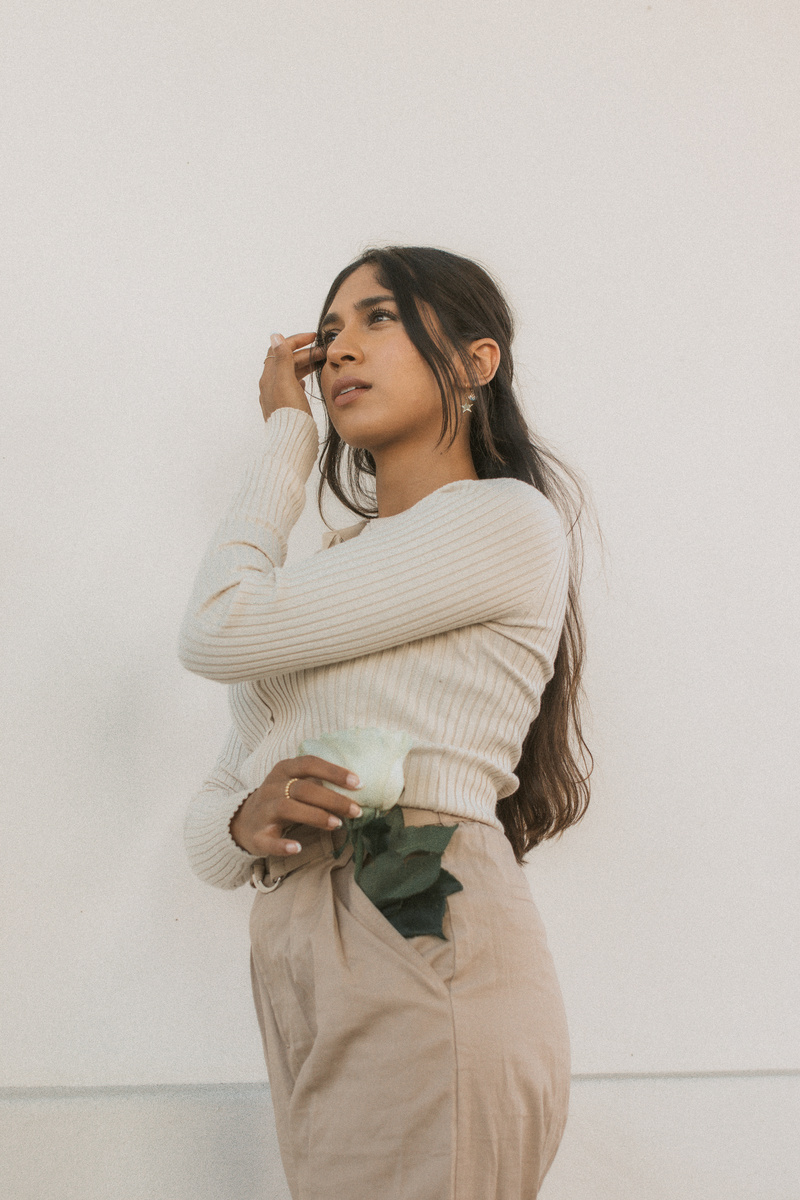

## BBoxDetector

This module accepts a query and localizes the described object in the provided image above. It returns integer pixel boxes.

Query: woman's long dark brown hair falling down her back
[315,246,594,864]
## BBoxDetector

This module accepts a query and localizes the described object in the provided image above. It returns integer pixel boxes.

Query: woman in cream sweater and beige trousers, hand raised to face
[180,246,589,1200]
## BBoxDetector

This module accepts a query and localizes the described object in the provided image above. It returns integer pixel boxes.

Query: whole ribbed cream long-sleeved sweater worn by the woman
[179,408,569,888]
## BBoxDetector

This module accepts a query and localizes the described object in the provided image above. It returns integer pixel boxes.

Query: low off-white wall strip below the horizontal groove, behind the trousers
[6,1075,800,1200]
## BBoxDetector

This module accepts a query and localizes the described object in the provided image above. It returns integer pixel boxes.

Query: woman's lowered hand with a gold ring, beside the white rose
[230,755,361,858]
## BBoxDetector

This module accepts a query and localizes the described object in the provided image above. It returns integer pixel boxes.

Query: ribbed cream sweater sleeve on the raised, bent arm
[179,408,567,683]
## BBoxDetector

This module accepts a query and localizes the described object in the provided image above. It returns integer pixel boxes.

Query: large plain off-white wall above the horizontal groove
[0,0,800,1190]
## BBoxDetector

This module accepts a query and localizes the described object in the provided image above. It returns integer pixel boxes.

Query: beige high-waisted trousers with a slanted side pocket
[251,806,570,1200]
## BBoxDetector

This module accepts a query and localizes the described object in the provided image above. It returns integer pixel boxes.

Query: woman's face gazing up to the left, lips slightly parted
[320,263,455,451]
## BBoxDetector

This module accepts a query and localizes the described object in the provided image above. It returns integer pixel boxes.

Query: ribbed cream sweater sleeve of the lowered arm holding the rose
[184,725,258,888]
